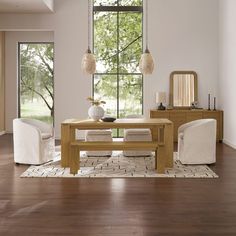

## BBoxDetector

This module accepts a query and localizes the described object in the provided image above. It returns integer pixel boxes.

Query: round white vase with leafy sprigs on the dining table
[87,97,106,121]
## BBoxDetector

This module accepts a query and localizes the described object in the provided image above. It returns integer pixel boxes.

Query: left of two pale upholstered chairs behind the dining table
[85,129,112,156]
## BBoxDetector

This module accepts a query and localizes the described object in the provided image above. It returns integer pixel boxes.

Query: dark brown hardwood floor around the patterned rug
[0,135,236,236]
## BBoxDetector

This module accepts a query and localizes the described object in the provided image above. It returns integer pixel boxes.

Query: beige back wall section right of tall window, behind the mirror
[145,0,218,114]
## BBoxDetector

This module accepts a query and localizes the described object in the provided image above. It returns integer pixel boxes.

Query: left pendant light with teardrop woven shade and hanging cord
[81,0,96,74]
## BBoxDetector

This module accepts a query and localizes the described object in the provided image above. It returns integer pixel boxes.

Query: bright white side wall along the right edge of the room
[219,0,236,148]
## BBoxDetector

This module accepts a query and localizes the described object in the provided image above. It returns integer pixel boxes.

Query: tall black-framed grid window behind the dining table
[93,0,143,135]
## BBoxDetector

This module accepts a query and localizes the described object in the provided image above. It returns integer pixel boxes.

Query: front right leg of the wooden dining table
[164,123,174,168]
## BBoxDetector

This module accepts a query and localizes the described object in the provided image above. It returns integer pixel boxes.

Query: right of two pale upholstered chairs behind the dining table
[123,115,152,156]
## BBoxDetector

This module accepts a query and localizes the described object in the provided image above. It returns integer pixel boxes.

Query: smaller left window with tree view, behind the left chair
[19,43,54,124]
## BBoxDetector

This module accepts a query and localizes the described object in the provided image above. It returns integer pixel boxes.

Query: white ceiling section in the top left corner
[0,0,53,13]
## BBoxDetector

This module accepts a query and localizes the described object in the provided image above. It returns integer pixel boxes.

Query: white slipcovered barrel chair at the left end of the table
[13,118,55,165]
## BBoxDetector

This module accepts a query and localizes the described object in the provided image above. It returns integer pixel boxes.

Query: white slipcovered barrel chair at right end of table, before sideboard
[178,119,216,164]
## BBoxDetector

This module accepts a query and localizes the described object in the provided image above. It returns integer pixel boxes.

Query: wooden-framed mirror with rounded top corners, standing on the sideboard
[169,71,198,108]
